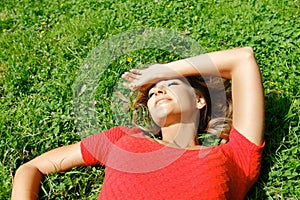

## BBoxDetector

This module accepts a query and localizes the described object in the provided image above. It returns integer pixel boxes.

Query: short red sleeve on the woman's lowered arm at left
[80,126,128,165]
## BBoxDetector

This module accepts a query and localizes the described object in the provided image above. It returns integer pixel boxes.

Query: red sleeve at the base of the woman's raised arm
[224,127,265,183]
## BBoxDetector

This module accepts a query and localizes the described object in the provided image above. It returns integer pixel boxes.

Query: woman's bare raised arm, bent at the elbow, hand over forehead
[123,47,264,145]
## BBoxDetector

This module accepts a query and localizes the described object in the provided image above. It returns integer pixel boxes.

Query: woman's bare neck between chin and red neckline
[161,123,197,148]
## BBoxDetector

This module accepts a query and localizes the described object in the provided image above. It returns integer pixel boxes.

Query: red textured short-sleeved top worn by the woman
[81,126,264,200]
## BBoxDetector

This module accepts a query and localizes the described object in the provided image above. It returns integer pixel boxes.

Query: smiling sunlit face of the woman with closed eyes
[147,79,199,127]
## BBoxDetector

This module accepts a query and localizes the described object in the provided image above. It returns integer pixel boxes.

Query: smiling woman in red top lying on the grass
[12,47,264,200]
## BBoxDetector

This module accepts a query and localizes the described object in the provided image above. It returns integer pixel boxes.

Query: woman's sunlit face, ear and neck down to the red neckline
[147,79,205,148]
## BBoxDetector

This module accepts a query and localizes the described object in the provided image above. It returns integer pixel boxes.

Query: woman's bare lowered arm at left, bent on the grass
[11,142,84,200]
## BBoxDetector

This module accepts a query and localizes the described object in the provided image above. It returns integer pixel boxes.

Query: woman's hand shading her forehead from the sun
[122,64,181,91]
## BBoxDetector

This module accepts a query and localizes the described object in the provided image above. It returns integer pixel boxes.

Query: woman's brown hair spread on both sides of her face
[132,76,232,143]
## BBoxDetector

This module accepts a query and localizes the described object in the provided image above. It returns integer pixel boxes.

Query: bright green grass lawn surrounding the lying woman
[0,0,300,199]
